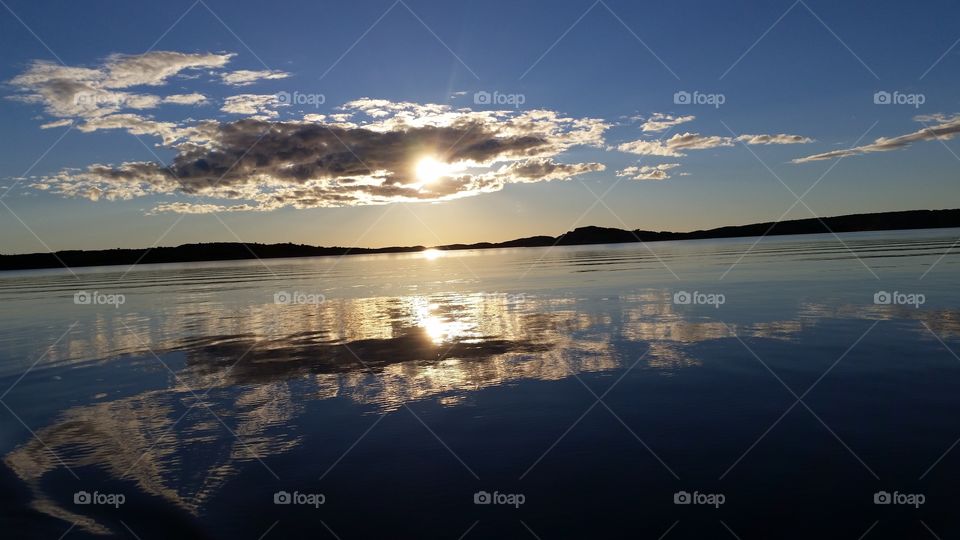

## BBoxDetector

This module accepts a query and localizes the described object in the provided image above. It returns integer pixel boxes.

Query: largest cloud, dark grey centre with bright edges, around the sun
[33,100,607,213]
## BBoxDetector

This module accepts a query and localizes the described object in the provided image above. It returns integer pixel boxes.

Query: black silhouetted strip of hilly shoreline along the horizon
[0,209,960,271]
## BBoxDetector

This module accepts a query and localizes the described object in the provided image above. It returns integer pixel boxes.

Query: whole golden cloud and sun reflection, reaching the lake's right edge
[4,233,960,533]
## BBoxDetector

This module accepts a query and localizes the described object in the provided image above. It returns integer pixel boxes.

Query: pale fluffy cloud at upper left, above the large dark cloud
[9,51,233,118]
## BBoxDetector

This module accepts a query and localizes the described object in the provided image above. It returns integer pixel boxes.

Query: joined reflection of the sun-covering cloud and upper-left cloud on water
[4,293,632,533]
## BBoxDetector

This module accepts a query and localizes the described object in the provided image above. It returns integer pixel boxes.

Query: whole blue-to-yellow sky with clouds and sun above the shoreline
[0,0,960,253]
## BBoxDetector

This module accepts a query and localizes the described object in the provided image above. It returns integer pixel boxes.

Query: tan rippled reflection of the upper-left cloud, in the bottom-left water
[4,383,302,534]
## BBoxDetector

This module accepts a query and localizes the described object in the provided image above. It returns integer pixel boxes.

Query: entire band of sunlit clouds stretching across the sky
[8,51,832,213]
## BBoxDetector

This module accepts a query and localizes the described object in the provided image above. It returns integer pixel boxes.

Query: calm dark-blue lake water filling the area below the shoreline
[0,229,960,540]
